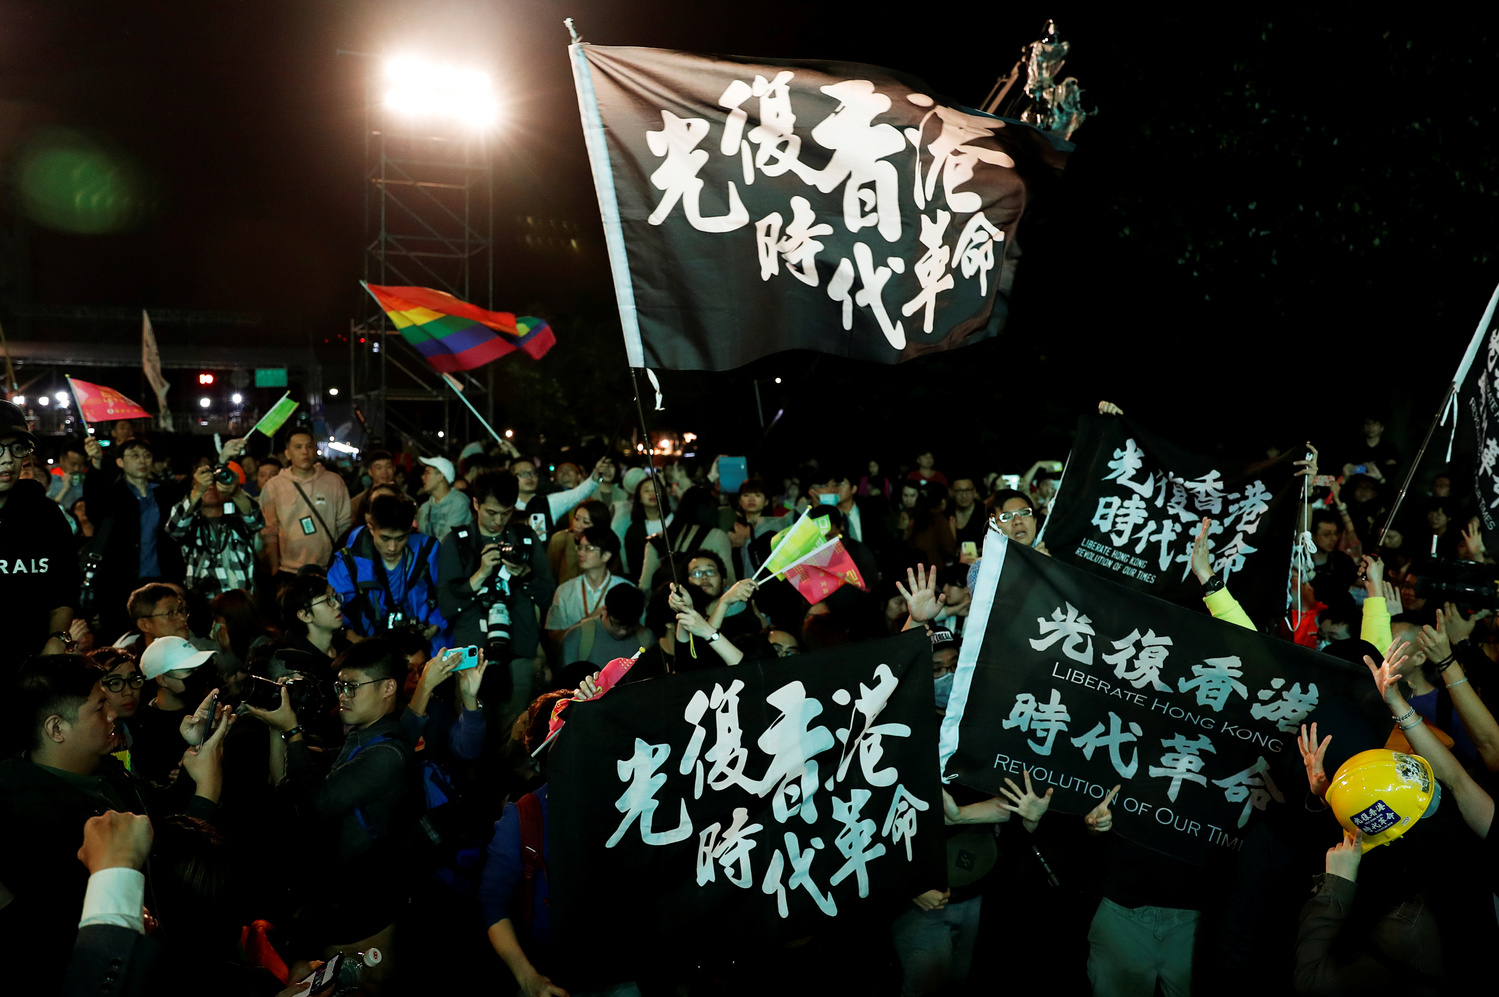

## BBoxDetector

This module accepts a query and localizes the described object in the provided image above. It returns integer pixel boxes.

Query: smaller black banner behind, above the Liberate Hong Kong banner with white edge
[1042,412,1301,627]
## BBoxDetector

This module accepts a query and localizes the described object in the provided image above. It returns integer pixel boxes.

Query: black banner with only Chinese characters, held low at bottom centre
[547,630,946,960]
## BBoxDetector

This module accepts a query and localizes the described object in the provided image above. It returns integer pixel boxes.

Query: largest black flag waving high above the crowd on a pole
[571,45,1072,370]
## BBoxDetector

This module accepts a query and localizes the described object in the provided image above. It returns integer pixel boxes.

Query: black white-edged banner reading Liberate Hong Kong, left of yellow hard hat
[941,532,1390,862]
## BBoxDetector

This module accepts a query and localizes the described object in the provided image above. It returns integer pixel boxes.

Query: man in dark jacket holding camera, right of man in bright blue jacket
[438,471,556,712]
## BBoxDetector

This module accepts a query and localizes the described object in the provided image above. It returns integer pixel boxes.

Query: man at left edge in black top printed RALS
[0,402,78,661]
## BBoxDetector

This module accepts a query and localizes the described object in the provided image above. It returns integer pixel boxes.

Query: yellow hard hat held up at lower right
[1327,748,1442,852]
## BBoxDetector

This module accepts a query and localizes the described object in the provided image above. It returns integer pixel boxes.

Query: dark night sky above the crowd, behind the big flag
[0,0,1499,471]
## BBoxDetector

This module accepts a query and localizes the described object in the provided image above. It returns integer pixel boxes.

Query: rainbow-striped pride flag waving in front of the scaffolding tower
[361,282,556,373]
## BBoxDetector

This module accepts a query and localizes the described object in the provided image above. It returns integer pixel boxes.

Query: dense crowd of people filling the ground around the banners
[0,402,1499,997]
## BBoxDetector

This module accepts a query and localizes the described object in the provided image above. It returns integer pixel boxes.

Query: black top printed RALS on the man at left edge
[0,480,78,660]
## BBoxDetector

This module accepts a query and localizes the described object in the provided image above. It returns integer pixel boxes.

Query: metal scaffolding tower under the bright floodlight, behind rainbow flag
[349,73,495,445]
